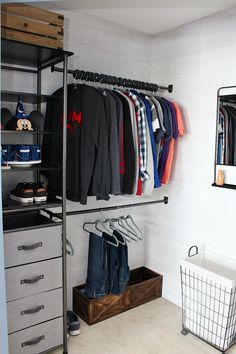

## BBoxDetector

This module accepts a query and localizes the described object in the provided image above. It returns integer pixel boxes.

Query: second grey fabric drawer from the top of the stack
[6,258,62,301]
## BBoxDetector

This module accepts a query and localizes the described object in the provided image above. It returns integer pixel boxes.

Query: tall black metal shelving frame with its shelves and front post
[1,38,70,353]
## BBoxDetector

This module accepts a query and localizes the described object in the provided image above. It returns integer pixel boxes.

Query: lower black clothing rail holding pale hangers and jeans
[44,196,168,219]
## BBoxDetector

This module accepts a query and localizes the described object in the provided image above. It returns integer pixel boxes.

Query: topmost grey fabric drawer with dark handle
[4,225,62,268]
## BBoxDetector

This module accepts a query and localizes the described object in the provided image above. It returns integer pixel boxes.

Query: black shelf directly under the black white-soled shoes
[2,198,62,215]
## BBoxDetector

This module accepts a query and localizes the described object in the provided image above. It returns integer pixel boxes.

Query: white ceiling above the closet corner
[33,0,236,35]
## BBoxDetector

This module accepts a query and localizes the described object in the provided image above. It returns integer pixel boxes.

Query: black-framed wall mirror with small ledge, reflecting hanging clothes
[213,86,236,189]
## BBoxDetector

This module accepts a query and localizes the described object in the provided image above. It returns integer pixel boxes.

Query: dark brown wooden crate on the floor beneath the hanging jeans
[73,267,163,325]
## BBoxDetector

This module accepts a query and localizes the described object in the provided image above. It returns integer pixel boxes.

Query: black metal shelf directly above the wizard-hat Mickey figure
[1,90,62,104]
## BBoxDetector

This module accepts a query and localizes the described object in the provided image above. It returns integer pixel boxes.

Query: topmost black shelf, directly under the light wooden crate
[1,38,73,70]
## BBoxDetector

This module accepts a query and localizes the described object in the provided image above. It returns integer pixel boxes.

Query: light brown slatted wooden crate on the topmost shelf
[1,3,64,49]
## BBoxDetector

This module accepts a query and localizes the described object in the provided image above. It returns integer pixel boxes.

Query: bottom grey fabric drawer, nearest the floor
[8,317,63,354]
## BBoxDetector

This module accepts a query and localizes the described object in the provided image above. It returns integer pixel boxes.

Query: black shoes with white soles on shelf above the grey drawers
[9,182,47,204]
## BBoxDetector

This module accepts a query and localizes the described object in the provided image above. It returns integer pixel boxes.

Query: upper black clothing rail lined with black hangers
[51,65,173,93]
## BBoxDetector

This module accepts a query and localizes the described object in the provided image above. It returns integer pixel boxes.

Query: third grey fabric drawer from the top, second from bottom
[7,289,62,333]
